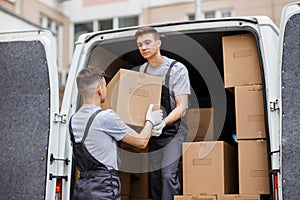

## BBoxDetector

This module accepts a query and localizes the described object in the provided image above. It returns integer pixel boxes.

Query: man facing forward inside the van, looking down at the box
[135,26,190,200]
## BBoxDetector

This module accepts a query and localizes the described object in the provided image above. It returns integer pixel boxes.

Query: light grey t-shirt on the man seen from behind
[72,104,130,170]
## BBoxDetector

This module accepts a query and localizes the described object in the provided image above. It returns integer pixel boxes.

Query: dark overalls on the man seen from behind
[69,109,120,200]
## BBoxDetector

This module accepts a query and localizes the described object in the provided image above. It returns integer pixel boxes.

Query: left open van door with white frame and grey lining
[0,30,59,200]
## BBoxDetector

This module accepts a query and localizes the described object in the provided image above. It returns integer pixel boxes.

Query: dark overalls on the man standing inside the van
[144,61,186,200]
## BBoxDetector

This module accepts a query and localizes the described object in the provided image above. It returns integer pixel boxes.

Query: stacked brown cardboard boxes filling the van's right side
[175,34,270,200]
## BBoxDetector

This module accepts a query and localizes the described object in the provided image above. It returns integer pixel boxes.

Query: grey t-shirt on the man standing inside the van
[140,56,191,109]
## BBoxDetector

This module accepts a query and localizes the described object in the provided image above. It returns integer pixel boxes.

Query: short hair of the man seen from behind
[76,66,104,97]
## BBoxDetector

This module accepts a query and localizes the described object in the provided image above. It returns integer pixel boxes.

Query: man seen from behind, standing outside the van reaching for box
[69,67,163,200]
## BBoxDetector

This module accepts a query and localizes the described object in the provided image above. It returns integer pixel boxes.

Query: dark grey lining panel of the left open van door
[0,41,50,200]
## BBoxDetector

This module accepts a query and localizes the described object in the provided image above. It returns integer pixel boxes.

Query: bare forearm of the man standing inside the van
[164,94,188,125]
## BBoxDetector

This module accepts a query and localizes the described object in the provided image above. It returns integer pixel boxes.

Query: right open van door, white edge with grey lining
[278,3,300,200]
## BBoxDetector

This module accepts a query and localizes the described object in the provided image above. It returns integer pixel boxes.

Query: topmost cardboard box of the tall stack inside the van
[222,34,262,88]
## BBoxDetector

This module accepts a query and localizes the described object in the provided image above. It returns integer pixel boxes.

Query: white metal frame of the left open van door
[0,30,59,199]
